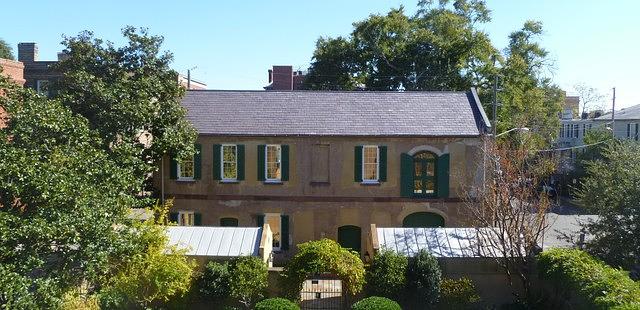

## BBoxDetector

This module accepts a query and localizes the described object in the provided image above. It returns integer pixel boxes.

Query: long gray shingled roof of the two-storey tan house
[182,90,489,136]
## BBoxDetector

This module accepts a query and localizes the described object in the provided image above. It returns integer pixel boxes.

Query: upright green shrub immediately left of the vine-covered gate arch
[229,256,268,309]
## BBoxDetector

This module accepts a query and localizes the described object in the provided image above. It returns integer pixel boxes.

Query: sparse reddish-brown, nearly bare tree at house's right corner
[467,140,555,302]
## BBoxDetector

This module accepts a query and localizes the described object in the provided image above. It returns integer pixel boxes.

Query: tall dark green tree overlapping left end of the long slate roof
[56,27,196,179]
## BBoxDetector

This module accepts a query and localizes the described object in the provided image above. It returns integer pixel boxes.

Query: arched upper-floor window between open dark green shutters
[413,151,438,197]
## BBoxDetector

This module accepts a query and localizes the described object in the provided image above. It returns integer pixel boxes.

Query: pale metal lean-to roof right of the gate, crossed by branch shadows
[376,227,504,257]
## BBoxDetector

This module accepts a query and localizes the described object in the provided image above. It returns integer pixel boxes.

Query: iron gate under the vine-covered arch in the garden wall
[300,274,346,310]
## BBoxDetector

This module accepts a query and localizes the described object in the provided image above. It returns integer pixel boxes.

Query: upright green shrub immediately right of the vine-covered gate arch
[366,249,408,300]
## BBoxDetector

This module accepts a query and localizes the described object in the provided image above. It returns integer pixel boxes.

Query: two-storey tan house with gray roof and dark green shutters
[154,90,490,260]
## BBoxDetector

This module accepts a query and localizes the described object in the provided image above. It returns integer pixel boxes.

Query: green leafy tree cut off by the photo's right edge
[576,141,640,270]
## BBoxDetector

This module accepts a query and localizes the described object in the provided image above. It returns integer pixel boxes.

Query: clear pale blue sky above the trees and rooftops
[0,0,640,107]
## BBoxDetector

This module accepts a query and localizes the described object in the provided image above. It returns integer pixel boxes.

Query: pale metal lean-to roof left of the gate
[167,226,262,257]
